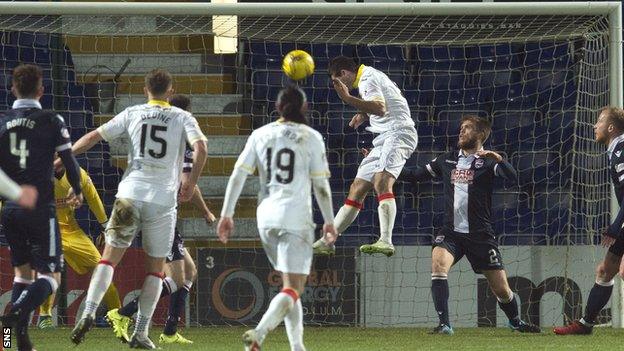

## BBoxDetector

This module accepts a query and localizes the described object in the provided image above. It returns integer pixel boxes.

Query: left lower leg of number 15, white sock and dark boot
[70,244,126,345]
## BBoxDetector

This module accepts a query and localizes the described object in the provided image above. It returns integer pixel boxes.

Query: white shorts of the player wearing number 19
[258,228,314,275]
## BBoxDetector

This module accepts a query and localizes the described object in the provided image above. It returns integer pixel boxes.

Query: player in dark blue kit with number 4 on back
[0,65,82,351]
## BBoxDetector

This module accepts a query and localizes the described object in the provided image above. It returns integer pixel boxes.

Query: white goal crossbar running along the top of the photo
[0,1,621,16]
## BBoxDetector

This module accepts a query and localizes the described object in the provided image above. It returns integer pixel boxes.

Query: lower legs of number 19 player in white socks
[243,273,308,351]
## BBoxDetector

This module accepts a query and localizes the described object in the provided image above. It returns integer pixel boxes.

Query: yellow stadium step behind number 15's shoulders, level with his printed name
[93,115,251,138]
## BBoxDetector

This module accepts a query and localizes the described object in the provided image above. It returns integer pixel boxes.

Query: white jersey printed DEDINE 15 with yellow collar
[98,101,206,206]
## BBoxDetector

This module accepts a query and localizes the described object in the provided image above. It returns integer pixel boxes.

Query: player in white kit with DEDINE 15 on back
[71,69,207,349]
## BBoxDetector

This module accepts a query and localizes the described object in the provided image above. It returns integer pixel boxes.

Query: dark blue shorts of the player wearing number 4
[0,205,63,273]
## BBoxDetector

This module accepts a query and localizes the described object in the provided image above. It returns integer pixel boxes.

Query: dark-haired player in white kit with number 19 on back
[217,87,337,351]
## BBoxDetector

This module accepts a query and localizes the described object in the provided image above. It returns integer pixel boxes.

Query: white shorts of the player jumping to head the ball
[355,127,418,183]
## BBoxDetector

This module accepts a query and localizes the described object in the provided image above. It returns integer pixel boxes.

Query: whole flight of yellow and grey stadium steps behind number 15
[64,31,255,241]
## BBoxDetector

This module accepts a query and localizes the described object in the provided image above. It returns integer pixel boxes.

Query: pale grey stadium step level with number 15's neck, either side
[115,94,243,114]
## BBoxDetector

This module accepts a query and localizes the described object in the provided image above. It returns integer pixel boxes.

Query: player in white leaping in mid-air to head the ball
[314,56,418,256]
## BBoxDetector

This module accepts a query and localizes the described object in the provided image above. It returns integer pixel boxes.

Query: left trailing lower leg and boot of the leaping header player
[312,178,373,255]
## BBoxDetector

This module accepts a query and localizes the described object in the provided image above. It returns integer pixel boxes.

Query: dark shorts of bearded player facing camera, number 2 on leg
[433,231,504,273]
